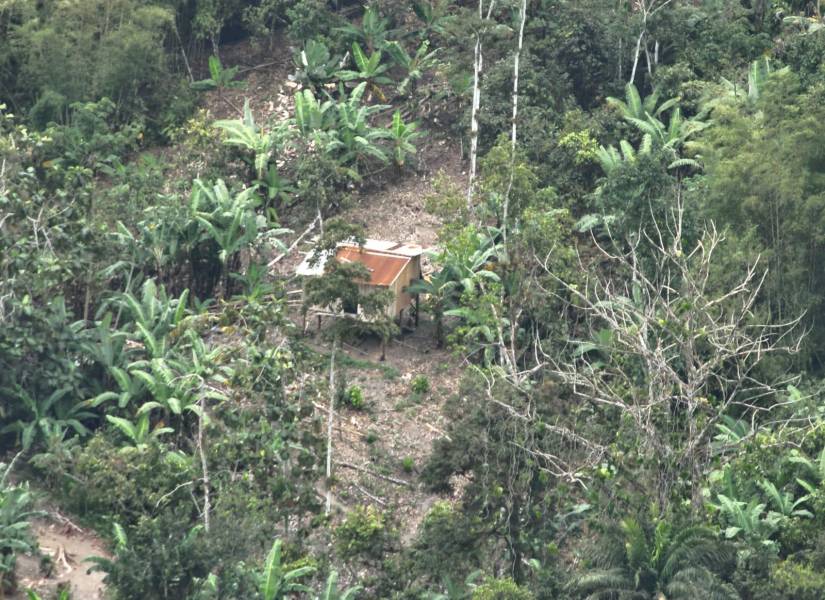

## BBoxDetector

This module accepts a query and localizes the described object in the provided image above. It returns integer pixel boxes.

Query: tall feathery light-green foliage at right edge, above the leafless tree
[702,72,825,358]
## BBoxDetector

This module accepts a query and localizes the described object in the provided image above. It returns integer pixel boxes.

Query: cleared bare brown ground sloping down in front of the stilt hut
[308,319,459,542]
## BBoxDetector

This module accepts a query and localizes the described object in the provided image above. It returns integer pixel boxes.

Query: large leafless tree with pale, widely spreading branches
[544,209,802,508]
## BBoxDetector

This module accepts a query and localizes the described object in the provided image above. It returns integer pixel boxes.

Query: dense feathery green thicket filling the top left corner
[4,0,175,121]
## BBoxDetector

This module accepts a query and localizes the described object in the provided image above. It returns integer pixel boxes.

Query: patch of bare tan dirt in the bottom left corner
[10,520,107,600]
